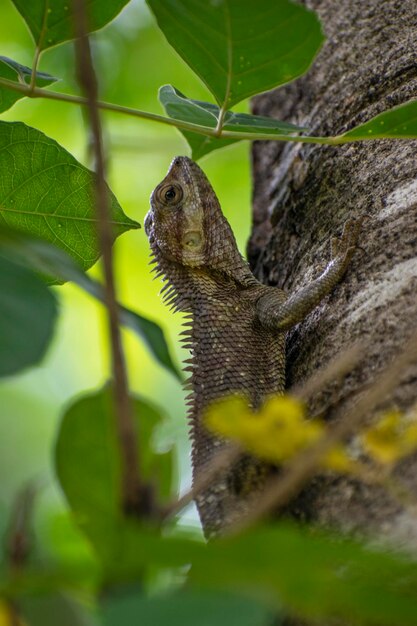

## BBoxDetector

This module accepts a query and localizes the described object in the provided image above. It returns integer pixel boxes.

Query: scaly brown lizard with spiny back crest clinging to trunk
[145,156,361,537]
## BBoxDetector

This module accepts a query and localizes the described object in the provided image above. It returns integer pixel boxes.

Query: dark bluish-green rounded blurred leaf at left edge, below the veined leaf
[0,256,57,376]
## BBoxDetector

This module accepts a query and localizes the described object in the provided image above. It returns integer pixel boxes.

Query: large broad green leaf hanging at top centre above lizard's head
[147,0,323,109]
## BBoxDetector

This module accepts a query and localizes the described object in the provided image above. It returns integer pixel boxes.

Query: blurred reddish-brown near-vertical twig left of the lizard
[73,0,146,516]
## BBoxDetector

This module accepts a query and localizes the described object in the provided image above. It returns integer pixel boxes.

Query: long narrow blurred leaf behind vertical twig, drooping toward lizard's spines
[0,227,182,380]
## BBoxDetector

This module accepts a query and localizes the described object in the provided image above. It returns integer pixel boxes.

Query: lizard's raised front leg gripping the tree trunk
[257,219,362,331]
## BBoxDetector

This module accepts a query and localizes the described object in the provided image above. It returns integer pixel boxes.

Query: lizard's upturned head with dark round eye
[145,157,243,273]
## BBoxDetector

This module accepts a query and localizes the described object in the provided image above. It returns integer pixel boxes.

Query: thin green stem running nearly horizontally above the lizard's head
[0,78,415,146]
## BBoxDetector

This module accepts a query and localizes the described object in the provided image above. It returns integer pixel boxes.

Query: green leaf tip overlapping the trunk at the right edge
[337,100,417,140]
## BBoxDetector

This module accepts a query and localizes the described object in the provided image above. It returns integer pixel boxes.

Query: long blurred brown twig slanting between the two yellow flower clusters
[230,333,417,534]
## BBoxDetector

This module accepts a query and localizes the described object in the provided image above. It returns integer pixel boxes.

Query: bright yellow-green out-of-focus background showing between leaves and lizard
[0,0,250,540]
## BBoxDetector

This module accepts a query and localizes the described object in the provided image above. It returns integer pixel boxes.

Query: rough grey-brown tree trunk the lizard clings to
[248,0,417,547]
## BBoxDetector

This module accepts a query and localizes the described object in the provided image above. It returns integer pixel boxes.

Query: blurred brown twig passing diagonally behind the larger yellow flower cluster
[165,344,363,517]
